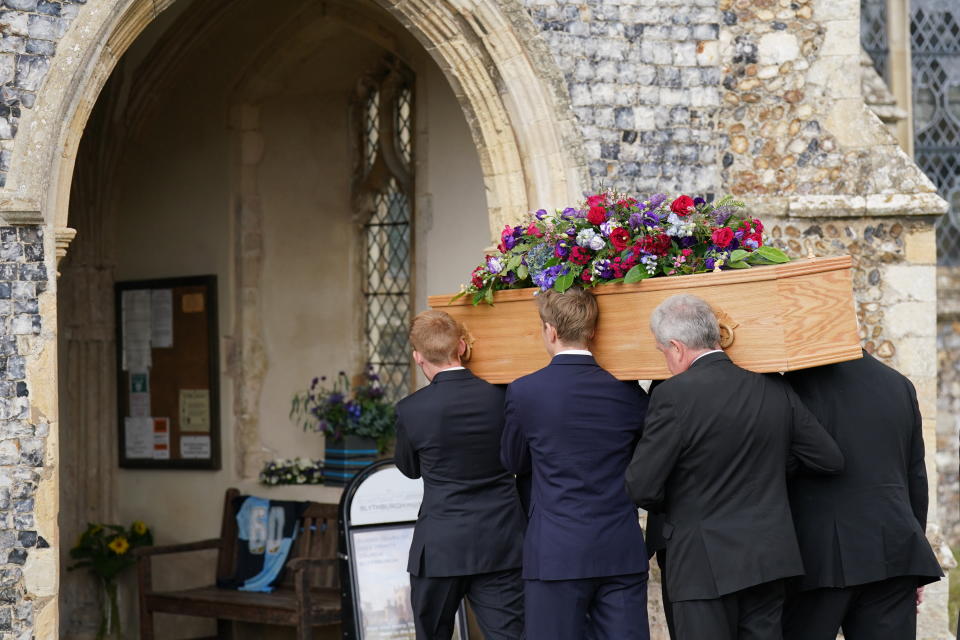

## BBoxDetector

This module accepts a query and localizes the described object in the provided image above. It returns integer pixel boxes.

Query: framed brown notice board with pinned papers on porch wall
[115,276,220,469]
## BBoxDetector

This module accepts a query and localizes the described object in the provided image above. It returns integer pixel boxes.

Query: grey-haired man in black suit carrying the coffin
[626,295,843,640]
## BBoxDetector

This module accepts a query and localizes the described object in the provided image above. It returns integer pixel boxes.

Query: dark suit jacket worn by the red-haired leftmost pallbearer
[396,369,526,578]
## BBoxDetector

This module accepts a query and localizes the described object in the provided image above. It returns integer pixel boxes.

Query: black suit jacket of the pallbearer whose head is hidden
[786,352,942,589]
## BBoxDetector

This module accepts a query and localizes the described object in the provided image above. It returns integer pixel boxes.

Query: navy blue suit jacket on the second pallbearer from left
[502,355,648,580]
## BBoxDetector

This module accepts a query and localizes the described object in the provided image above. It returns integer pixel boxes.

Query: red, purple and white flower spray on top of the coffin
[455,192,789,304]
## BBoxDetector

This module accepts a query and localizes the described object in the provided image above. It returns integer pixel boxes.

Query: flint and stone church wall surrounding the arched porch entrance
[0,0,944,640]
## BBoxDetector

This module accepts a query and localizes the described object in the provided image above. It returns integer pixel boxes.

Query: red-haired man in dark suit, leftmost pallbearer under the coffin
[396,311,526,640]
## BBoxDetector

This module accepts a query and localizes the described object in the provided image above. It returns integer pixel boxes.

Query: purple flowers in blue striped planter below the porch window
[290,366,396,485]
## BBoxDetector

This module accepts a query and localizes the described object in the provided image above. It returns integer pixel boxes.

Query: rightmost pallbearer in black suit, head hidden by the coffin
[783,352,942,640]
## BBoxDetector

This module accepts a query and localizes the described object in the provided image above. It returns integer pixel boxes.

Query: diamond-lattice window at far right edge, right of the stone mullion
[910,0,960,265]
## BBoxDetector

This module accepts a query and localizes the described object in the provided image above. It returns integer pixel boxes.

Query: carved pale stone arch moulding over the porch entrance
[13,0,586,244]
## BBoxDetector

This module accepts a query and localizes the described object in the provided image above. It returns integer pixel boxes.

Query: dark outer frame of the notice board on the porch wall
[114,275,222,471]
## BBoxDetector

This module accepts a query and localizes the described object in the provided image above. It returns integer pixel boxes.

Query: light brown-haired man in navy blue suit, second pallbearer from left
[502,288,649,640]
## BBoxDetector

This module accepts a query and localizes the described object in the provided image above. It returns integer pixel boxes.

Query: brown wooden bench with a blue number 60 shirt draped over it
[134,489,340,640]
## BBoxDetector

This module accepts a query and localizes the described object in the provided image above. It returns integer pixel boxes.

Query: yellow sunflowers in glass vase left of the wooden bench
[70,520,153,639]
